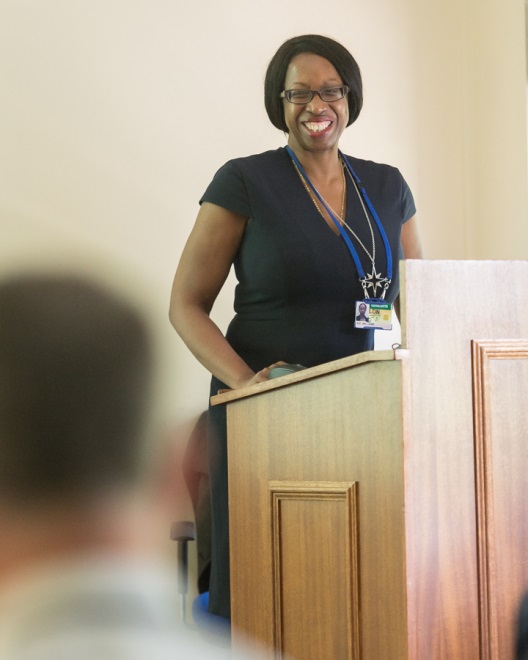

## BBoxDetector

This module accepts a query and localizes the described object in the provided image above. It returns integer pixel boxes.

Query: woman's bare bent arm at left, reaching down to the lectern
[169,202,268,389]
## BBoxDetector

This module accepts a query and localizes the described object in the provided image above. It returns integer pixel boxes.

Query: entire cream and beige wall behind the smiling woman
[0,0,528,424]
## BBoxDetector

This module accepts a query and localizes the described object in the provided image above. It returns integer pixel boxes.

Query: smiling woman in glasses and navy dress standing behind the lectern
[170,29,421,617]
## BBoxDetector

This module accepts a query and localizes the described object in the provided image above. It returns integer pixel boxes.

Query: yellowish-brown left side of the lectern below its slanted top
[228,356,407,660]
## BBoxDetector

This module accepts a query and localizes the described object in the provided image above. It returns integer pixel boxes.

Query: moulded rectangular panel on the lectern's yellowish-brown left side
[269,482,360,660]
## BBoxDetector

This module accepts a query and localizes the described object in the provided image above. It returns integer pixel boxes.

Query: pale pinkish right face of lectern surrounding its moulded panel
[401,261,528,660]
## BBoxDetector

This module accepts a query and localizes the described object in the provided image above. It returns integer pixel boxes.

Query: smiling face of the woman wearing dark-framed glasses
[283,53,349,156]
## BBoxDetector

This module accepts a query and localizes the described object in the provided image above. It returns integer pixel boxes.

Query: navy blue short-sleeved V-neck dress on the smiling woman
[201,148,415,617]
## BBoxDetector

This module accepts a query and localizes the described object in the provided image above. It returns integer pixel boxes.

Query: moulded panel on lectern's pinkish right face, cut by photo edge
[472,340,528,660]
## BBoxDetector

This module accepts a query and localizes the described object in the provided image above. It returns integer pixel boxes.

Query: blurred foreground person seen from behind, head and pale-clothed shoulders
[0,273,227,660]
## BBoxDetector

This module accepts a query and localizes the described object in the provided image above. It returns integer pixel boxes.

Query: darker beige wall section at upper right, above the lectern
[412,0,528,259]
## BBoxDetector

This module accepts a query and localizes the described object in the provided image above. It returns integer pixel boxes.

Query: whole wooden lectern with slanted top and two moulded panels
[213,261,528,660]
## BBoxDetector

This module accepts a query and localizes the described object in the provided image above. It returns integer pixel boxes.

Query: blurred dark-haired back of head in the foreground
[0,274,163,561]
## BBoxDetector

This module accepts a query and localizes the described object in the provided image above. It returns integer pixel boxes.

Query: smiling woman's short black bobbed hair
[264,34,363,133]
